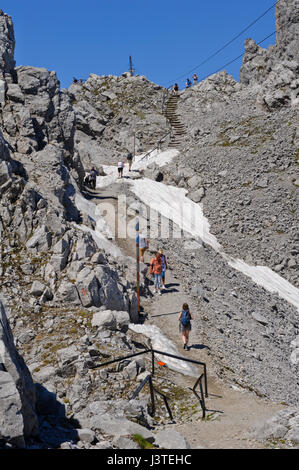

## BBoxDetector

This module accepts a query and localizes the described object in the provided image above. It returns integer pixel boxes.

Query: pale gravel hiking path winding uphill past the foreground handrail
[98,182,283,449]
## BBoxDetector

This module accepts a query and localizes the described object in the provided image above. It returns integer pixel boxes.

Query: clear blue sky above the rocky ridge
[0,0,275,88]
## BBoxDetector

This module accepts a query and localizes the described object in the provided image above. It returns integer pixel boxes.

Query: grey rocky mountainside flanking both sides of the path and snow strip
[0,0,299,449]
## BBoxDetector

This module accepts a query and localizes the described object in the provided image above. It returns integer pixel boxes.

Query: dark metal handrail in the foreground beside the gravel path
[89,348,208,419]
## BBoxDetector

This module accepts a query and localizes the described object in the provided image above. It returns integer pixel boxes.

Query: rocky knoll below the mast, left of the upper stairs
[67,73,169,168]
